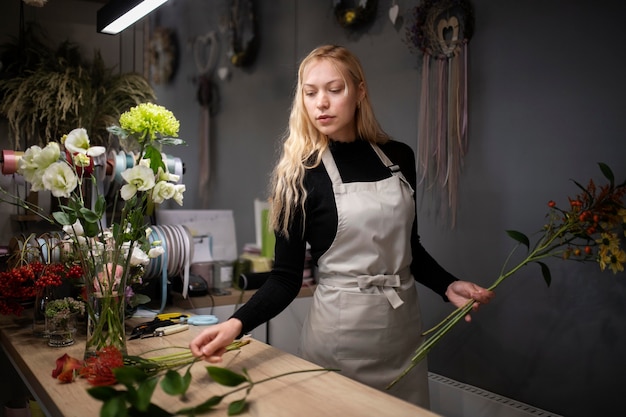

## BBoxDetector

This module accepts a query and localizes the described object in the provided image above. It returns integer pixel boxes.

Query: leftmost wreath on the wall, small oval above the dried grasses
[149,28,178,84]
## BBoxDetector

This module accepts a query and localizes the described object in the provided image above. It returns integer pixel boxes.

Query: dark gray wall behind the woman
[2,0,626,417]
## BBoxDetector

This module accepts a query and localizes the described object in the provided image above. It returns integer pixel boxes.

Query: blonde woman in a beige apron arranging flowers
[190,45,493,407]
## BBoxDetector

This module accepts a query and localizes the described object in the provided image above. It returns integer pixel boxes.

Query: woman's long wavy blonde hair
[270,45,389,237]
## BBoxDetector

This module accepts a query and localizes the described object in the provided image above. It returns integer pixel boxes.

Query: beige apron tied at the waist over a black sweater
[300,145,429,408]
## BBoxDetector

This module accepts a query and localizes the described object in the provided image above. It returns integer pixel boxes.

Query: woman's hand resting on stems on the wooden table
[189,319,243,363]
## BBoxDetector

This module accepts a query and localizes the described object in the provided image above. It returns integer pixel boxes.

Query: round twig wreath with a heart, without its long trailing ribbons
[407,0,474,57]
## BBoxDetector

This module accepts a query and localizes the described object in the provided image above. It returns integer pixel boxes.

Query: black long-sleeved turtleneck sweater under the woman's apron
[233,140,456,333]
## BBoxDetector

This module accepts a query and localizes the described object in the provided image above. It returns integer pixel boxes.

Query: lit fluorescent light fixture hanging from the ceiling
[97,0,167,35]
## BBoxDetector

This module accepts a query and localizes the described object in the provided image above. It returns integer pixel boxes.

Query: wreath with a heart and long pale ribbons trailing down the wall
[407,0,474,228]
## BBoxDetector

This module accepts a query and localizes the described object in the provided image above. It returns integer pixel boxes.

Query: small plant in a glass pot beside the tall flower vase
[46,297,85,347]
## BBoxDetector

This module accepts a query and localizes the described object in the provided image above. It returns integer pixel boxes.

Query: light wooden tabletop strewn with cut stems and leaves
[0,317,436,417]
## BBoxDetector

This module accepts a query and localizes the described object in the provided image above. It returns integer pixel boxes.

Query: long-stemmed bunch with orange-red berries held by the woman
[387,163,626,389]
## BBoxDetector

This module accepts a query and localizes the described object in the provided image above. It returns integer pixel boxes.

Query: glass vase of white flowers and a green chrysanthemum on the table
[0,103,185,357]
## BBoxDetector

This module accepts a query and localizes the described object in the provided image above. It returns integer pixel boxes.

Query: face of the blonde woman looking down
[302,59,365,142]
